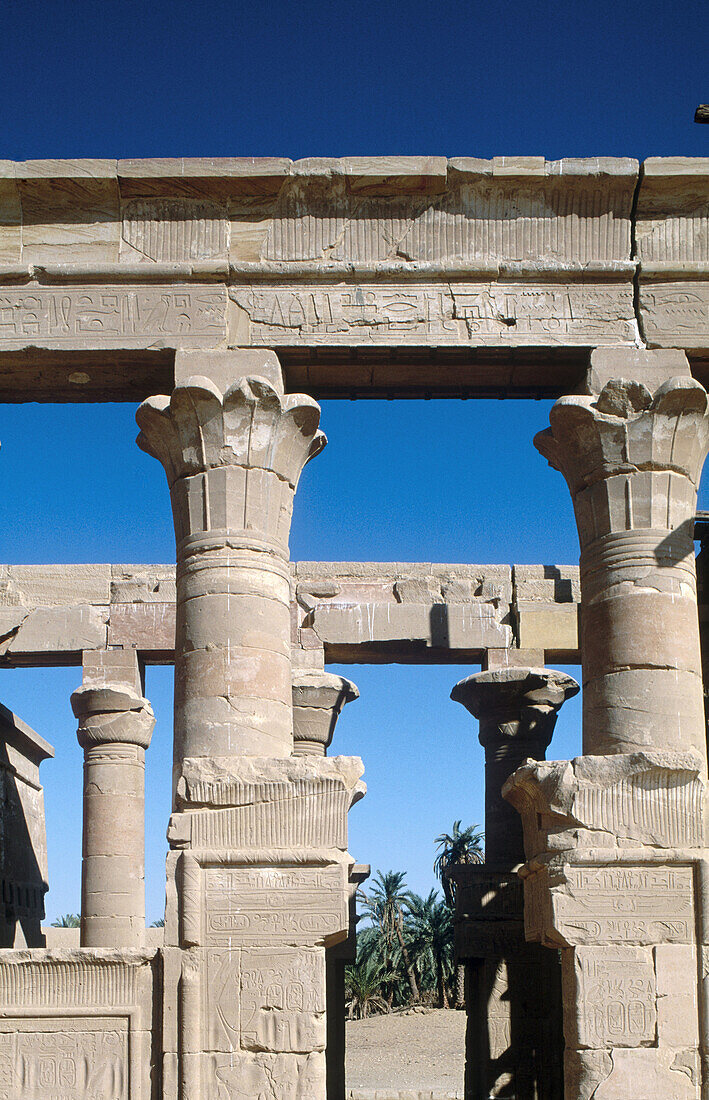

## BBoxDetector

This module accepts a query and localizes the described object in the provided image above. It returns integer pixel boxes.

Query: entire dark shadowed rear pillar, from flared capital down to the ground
[451,667,578,1100]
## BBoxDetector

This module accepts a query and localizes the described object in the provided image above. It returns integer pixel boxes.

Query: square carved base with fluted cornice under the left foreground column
[163,757,364,1100]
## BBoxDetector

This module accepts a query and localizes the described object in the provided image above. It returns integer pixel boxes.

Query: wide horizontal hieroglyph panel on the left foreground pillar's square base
[203,865,347,947]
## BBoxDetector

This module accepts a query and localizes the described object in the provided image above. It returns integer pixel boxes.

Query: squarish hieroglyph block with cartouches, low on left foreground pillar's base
[241,948,325,1054]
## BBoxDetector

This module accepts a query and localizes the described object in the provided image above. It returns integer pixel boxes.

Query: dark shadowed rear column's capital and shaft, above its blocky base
[451,668,578,869]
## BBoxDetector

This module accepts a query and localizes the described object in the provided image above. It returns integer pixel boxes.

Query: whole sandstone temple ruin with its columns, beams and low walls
[0,157,709,1100]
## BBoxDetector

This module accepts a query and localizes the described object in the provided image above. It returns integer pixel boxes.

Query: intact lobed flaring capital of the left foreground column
[135,376,326,550]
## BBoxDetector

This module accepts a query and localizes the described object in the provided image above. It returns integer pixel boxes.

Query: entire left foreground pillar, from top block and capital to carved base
[137,350,364,1100]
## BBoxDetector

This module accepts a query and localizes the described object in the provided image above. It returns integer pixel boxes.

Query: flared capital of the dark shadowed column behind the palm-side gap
[451,667,579,751]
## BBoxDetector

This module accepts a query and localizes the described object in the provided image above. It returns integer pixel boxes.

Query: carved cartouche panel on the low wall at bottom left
[0,1016,129,1100]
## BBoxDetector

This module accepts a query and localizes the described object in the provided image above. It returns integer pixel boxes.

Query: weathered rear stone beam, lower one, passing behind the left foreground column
[0,562,602,669]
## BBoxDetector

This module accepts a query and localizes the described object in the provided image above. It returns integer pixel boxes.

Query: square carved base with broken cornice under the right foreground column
[505,752,709,1100]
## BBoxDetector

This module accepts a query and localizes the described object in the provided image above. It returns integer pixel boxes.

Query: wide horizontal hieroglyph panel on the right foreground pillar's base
[552,866,694,944]
